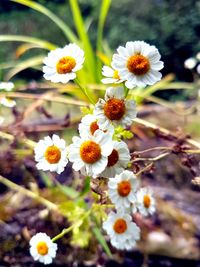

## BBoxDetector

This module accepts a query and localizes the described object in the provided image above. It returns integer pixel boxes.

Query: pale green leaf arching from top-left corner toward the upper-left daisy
[11,0,78,43]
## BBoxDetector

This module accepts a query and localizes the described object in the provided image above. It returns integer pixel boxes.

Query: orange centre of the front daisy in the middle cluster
[80,141,101,164]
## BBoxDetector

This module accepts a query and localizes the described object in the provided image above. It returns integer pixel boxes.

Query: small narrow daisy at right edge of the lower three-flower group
[136,187,156,216]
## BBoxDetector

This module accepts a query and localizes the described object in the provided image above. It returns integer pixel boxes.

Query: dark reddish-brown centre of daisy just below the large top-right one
[104,98,126,120]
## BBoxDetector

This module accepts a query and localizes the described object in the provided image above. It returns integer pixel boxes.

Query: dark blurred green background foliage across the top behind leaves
[0,0,200,81]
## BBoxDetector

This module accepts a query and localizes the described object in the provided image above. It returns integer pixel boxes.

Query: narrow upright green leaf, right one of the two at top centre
[96,0,111,81]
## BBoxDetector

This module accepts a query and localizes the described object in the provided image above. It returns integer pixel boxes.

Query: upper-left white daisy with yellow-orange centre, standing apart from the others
[43,44,84,83]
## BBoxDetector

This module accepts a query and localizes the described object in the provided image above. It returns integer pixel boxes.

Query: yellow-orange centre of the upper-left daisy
[56,56,76,74]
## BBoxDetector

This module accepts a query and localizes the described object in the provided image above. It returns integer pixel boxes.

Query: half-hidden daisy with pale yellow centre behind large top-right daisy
[101,66,123,84]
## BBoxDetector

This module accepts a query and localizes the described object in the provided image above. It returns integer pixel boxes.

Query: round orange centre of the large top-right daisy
[127,55,150,75]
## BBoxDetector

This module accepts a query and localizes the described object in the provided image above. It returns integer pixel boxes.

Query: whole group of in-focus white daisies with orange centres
[30,41,163,264]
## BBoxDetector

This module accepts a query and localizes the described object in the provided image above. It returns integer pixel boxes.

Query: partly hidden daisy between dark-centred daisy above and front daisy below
[78,114,114,138]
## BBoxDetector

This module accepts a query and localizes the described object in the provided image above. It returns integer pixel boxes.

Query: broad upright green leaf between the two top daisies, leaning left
[69,0,97,82]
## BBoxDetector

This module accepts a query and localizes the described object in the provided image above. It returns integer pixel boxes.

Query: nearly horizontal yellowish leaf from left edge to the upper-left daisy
[0,35,56,50]
